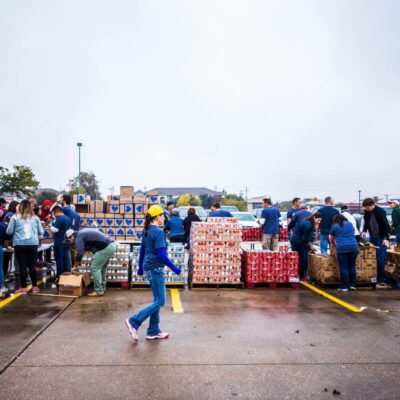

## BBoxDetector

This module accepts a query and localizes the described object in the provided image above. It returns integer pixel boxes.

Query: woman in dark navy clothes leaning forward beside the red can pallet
[290,212,322,279]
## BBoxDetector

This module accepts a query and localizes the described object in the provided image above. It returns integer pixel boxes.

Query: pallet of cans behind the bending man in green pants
[79,244,130,282]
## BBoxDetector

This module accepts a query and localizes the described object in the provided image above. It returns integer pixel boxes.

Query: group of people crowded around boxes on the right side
[261,196,400,291]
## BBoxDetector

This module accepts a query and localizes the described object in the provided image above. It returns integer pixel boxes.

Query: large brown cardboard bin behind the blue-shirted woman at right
[308,245,376,285]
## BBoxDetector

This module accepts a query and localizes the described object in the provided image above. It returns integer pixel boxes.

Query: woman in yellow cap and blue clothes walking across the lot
[125,206,181,342]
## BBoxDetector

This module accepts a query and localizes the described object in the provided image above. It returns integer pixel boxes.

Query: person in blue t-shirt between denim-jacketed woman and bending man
[50,205,71,278]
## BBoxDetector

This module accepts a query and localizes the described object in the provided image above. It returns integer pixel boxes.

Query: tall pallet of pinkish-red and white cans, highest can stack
[190,218,242,284]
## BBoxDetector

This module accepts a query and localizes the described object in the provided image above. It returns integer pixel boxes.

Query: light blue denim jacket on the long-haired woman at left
[7,215,44,246]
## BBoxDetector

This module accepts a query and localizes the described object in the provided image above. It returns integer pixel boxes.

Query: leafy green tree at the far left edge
[0,165,39,197]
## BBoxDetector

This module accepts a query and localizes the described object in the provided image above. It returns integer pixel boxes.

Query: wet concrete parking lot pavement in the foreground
[0,287,400,400]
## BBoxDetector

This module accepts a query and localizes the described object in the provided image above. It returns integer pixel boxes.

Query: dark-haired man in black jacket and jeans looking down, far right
[361,198,390,288]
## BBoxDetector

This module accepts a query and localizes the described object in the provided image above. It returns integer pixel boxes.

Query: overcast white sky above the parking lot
[0,0,400,200]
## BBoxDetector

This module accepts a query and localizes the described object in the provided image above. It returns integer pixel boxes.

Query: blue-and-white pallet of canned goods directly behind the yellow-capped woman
[131,243,187,286]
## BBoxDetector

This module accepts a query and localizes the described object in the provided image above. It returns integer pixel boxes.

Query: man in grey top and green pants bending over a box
[65,228,117,297]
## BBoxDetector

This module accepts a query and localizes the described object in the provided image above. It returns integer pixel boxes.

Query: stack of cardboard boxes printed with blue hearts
[74,186,158,241]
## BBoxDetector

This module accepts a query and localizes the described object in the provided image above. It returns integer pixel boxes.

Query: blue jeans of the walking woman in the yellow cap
[129,267,165,336]
